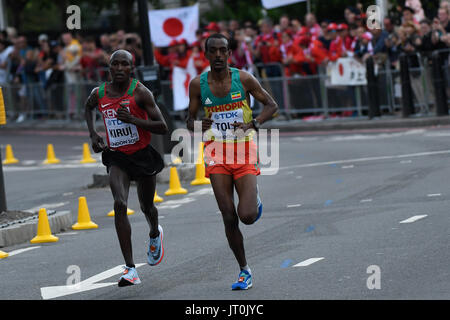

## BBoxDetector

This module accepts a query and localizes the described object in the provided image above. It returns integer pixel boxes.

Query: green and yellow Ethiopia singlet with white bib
[200,68,254,142]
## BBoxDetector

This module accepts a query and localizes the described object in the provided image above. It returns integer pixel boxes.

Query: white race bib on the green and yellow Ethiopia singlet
[211,109,244,140]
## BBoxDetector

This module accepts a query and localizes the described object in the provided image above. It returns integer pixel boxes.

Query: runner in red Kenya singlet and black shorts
[85,50,168,287]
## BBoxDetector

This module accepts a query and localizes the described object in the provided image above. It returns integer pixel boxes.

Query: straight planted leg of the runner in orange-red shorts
[210,174,247,268]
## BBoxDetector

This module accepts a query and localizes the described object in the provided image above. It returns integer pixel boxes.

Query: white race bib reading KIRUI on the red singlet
[105,118,139,148]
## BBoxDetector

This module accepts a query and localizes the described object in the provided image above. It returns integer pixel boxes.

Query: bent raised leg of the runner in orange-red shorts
[234,174,258,224]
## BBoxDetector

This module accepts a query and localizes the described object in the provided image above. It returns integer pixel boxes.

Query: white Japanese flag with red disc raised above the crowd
[148,4,199,47]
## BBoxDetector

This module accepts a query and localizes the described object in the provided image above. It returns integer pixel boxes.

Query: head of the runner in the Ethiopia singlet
[205,33,231,72]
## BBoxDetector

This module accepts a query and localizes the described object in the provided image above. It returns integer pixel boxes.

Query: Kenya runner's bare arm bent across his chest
[117,83,169,134]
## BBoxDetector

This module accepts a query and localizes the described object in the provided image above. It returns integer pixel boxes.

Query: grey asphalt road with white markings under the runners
[0,127,450,300]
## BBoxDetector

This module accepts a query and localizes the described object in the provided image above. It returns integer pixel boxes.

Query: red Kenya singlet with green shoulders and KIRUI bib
[98,79,151,154]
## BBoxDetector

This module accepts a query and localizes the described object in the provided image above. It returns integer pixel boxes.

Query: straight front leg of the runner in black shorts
[109,166,134,267]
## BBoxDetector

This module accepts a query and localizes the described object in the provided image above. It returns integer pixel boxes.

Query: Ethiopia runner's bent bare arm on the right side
[239,70,278,124]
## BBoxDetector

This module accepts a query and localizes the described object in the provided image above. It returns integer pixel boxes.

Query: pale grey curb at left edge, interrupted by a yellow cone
[0,211,73,248]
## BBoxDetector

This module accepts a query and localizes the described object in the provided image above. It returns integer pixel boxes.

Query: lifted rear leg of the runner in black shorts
[137,175,159,238]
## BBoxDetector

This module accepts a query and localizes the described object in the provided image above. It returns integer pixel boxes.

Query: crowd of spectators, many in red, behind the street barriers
[0,0,450,122]
